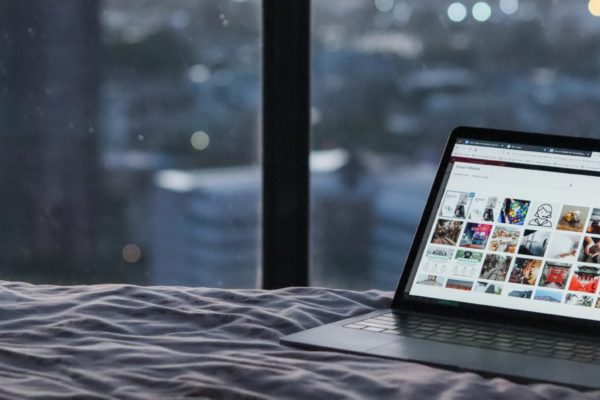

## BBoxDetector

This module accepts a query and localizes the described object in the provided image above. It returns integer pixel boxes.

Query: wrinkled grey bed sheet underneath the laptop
[0,282,600,399]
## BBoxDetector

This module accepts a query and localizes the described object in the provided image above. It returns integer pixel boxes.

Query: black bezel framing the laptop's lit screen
[392,126,600,335]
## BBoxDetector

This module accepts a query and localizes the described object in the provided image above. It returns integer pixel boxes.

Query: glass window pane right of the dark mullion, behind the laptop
[311,0,600,289]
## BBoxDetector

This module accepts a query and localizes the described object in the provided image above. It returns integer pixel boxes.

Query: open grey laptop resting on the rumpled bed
[281,127,600,389]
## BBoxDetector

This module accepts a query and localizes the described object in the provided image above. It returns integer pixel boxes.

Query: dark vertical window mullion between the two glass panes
[262,0,310,289]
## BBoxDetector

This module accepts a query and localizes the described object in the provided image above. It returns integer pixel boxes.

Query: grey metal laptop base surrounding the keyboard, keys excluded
[281,310,600,389]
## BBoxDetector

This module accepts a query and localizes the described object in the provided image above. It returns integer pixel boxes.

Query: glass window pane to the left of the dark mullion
[0,0,260,287]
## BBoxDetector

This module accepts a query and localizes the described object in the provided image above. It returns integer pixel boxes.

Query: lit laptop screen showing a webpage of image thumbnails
[406,138,600,321]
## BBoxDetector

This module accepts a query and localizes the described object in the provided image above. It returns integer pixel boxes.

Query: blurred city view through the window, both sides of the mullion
[0,0,600,289]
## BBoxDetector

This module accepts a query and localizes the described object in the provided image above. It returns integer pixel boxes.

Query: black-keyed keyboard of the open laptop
[344,313,600,364]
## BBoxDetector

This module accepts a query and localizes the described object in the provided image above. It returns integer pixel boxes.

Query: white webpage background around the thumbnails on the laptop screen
[410,162,600,321]
